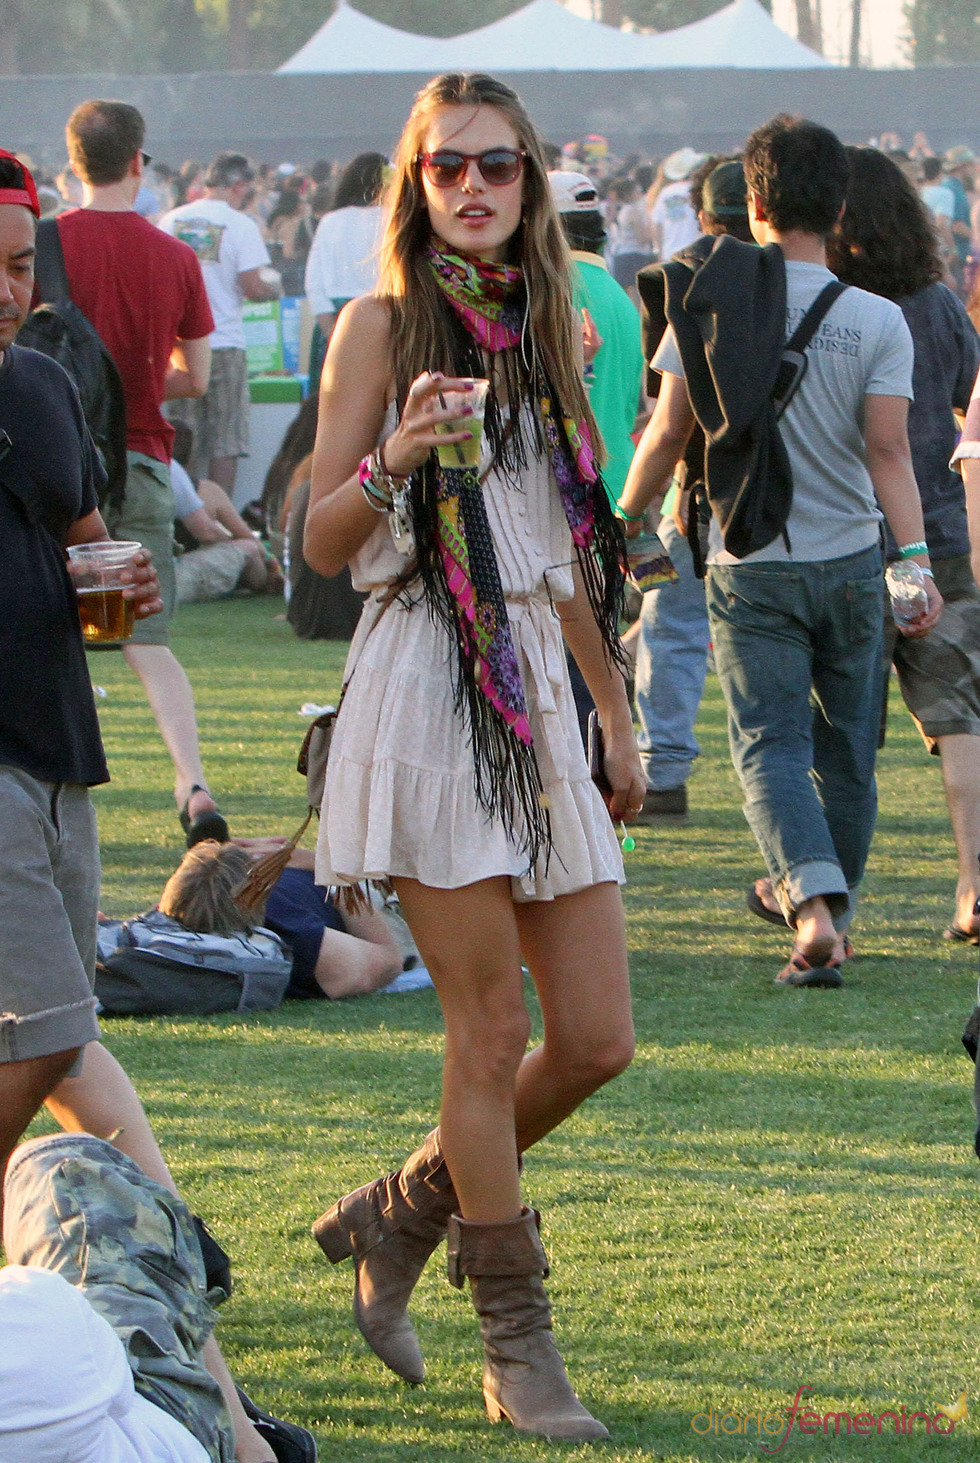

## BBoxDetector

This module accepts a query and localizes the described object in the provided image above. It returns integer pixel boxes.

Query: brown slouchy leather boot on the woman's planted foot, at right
[449,1208,608,1443]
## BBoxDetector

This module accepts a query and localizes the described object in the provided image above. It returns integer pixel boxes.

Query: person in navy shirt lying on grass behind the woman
[159,838,402,1001]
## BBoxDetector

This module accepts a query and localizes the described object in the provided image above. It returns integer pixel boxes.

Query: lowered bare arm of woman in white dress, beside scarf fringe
[556,565,647,821]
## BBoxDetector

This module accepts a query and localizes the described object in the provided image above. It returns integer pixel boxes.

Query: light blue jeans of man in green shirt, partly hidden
[636,518,708,791]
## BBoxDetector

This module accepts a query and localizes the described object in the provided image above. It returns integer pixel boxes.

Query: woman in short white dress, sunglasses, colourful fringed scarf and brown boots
[306,75,645,1438]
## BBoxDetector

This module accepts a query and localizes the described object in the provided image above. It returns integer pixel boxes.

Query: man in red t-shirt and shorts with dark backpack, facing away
[57,101,227,838]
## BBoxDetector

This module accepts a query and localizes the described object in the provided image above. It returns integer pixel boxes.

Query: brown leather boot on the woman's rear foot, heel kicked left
[313,1128,456,1383]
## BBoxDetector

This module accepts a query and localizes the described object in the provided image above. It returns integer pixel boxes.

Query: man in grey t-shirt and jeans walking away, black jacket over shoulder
[620,116,942,986]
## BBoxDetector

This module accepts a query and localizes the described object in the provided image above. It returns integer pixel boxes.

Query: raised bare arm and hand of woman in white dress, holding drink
[303,296,479,578]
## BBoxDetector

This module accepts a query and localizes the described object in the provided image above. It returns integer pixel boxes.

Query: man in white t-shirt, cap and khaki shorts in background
[159,152,279,496]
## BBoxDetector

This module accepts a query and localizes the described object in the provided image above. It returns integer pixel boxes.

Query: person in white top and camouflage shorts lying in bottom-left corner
[0,1132,316,1463]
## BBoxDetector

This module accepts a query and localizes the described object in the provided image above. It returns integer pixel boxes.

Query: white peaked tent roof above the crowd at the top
[279,0,831,75]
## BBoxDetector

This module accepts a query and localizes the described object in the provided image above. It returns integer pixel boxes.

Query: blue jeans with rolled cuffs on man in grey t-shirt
[708,546,882,928]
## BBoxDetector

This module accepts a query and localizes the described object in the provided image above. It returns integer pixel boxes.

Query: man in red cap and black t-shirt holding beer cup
[0,152,162,1211]
